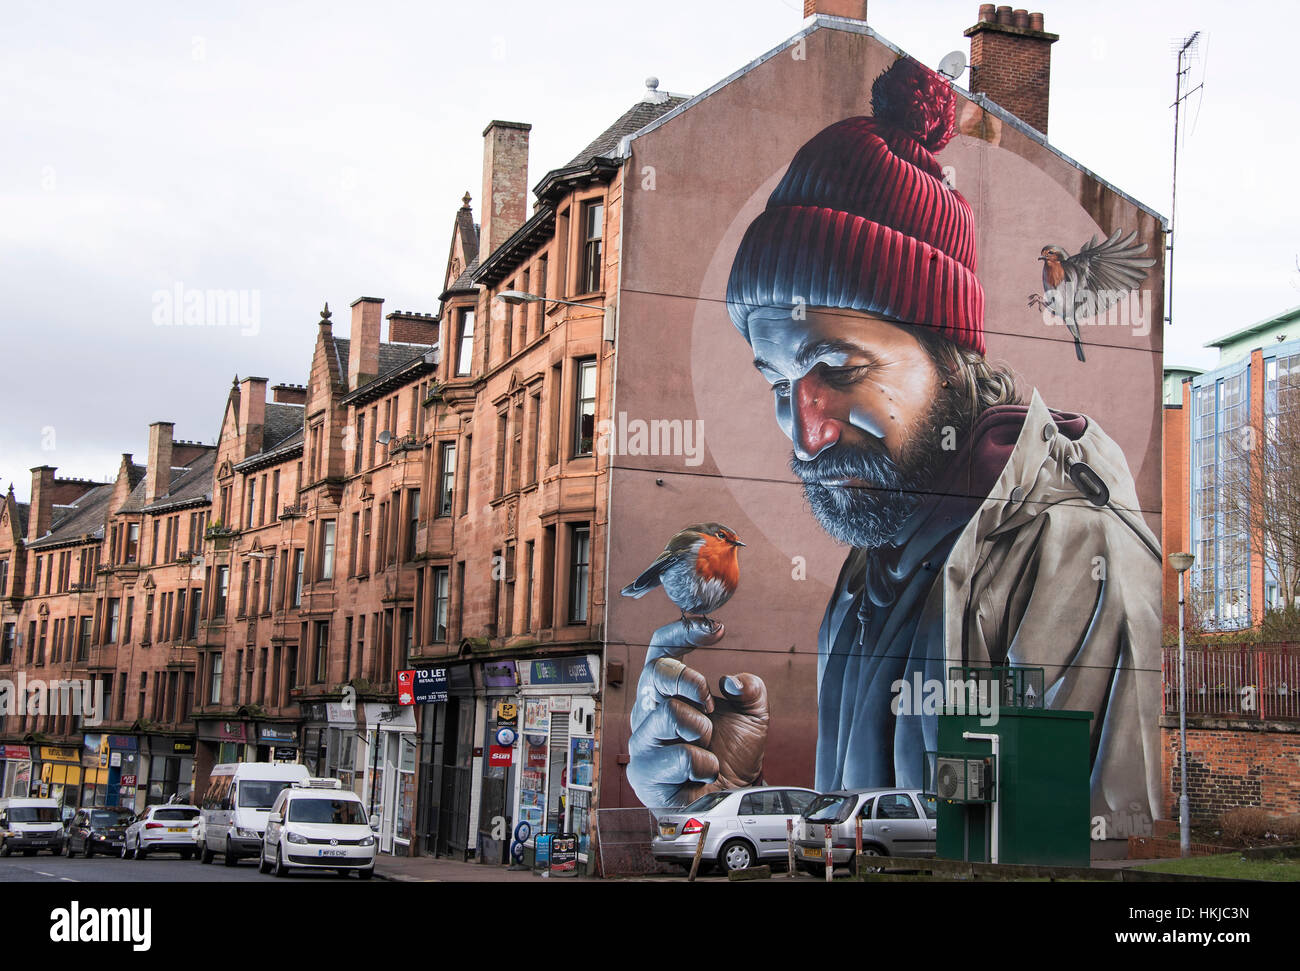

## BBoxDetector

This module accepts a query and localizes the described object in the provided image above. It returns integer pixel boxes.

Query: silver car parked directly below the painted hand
[650,785,816,871]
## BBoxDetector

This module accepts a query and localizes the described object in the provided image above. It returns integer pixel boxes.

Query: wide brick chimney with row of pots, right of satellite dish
[966,4,1060,135]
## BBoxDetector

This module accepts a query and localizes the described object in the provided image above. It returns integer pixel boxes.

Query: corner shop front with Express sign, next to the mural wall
[512,654,599,864]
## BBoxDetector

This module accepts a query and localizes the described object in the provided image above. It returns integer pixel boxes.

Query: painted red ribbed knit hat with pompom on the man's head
[727,57,984,354]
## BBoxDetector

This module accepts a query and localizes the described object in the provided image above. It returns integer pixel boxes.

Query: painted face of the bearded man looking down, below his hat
[749,309,957,549]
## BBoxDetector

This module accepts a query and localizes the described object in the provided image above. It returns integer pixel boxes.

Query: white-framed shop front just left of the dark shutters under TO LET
[361,703,417,857]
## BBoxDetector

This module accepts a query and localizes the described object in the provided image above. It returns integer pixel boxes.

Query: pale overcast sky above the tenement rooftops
[0,0,1300,499]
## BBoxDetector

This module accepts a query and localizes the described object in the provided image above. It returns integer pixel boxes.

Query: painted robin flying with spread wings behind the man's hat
[1030,229,1156,361]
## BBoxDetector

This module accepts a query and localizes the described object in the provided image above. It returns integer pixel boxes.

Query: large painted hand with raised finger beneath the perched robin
[628,621,768,809]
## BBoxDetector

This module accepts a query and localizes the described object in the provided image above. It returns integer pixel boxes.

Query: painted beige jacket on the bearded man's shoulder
[943,390,1164,824]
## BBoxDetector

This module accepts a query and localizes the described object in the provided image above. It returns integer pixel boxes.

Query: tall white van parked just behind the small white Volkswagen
[196,762,308,867]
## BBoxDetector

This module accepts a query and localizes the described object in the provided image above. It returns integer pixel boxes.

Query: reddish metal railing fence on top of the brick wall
[1161,645,1300,721]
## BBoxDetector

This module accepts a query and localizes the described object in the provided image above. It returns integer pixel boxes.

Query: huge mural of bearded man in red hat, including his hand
[628,58,1161,818]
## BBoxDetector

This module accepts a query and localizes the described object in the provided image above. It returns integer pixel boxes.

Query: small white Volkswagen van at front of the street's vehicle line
[257,779,380,880]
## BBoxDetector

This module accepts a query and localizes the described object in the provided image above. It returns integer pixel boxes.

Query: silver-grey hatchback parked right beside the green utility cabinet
[796,789,937,872]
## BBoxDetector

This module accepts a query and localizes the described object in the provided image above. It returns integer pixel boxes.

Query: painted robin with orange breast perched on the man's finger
[623,523,745,628]
